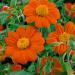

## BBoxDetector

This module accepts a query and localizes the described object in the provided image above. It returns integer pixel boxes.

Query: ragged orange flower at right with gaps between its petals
[46,21,75,54]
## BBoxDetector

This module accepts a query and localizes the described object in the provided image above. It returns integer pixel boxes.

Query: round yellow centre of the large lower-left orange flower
[17,37,29,49]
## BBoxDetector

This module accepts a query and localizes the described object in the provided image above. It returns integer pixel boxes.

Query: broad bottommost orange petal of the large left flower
[12,51,28,64]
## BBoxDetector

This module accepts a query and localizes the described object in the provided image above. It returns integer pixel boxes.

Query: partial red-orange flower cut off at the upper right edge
[65,3,75,18]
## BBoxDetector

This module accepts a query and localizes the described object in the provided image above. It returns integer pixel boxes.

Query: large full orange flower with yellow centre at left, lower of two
[5,26,44,64]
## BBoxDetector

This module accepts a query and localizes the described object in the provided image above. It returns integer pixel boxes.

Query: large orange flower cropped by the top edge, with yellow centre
[23,0,60,28]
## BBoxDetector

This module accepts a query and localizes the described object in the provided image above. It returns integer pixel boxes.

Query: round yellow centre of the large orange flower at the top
[36,5,48,16]
